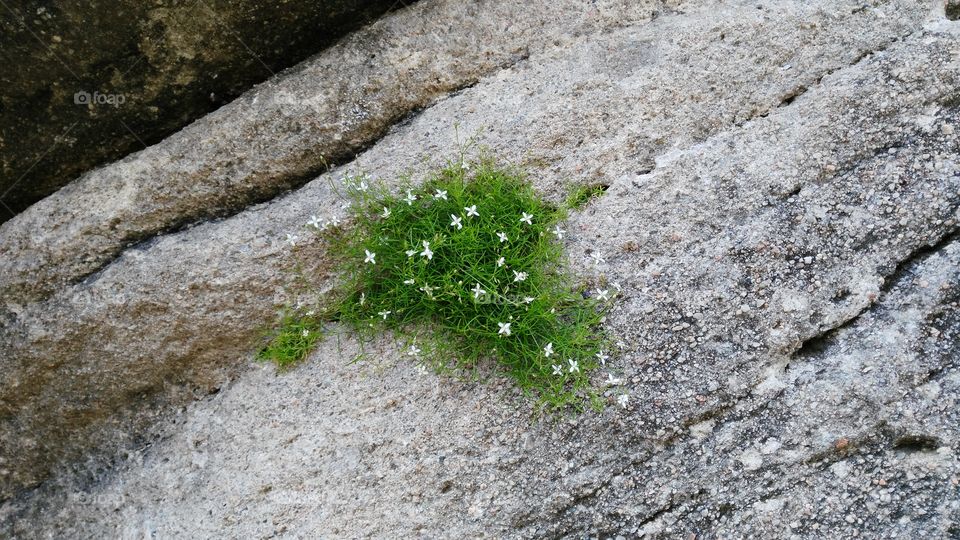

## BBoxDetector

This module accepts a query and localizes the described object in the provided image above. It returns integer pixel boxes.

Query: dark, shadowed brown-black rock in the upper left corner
[0,0,400,223]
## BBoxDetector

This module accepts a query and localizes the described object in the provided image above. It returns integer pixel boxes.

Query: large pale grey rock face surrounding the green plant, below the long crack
[0,1,960,538]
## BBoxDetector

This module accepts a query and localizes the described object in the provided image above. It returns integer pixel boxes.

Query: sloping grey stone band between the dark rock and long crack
[0,0,660,309]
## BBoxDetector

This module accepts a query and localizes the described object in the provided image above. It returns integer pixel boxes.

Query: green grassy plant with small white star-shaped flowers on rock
[264,160,625,410]
